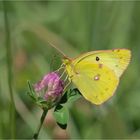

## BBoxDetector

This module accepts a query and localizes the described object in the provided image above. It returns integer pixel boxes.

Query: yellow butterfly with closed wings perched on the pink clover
[63,49,131,105]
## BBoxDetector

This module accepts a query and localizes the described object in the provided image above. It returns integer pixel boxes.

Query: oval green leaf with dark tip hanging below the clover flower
[54,104,69,129]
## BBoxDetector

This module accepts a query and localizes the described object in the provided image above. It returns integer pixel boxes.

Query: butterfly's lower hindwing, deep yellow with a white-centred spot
[71,63,119,105]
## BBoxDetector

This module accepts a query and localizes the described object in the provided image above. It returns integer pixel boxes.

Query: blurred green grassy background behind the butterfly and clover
[0,1,140,139]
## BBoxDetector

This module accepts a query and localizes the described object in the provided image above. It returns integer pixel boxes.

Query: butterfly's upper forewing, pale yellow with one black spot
[73,49,131,77]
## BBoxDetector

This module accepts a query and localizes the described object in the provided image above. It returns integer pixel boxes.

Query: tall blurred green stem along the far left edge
[3,0,15,139]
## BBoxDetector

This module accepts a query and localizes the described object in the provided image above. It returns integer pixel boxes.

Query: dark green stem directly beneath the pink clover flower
[33,109,48,140]
